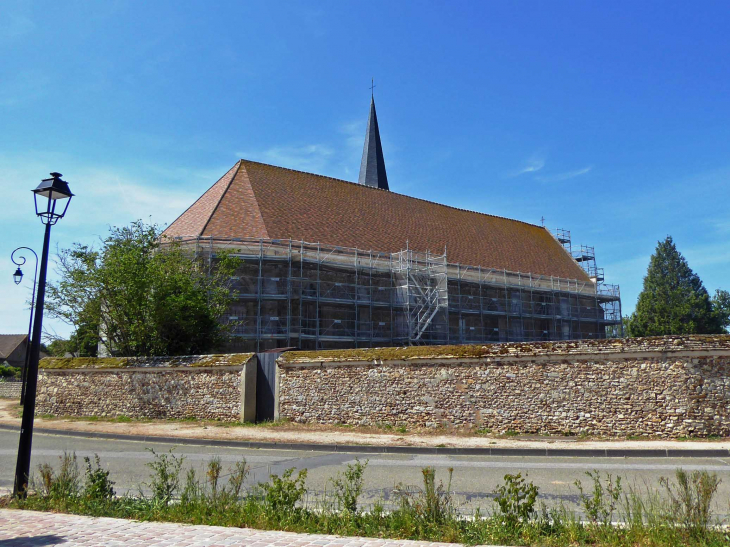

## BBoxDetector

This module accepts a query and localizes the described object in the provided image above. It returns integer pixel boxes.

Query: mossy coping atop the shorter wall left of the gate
[38,353,255,372]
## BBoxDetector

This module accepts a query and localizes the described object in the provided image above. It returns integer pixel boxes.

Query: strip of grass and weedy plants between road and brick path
[0,451,730,547]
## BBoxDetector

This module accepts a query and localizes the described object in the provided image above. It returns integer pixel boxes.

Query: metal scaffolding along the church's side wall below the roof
[176,237,621,351]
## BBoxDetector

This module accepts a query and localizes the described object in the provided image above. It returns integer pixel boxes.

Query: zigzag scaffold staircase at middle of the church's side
[394,249,449,345]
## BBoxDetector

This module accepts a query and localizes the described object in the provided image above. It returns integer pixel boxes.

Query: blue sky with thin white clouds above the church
[0,0,730,335]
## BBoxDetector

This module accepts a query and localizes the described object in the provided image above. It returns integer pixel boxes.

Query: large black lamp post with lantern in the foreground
[13,173,73,497]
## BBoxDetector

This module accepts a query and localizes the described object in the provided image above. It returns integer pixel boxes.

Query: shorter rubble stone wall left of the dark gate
[36,354,255,421]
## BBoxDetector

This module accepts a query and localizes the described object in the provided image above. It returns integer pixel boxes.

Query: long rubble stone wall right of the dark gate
[278,336,730,438]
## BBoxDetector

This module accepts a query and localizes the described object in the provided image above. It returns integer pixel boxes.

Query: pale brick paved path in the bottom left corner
[0,509,490,547]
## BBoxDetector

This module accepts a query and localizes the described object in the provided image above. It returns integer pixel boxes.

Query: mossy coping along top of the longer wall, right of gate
[278,334,730,366]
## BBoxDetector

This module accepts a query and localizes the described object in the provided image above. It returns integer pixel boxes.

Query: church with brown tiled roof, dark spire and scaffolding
[164,95,621,351]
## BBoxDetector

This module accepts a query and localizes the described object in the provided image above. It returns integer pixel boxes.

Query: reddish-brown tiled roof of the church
[164,160,588,281]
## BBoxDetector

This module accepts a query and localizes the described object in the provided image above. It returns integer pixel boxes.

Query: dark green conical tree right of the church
[628,237,730,336]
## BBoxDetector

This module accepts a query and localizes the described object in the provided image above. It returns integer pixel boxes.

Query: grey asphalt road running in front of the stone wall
[0,431,730,515]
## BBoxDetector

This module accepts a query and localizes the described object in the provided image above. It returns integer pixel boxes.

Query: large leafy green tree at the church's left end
[46,221,238,356]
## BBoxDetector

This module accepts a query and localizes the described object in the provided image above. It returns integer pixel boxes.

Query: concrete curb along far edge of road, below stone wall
[0,424,730,458]
